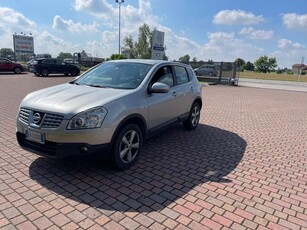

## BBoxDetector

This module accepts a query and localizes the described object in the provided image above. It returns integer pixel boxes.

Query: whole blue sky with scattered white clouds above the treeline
[0,0,307,68]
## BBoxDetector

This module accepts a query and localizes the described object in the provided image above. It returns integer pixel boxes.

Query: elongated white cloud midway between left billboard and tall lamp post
[52,15,99,33]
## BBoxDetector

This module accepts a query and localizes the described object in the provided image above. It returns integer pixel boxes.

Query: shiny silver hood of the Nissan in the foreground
[21,83,133,119]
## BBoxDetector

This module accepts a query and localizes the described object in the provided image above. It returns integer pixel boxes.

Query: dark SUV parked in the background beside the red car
[29,58,80,77]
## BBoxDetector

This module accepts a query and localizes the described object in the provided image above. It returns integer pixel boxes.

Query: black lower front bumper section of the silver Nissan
[16,131,111,159]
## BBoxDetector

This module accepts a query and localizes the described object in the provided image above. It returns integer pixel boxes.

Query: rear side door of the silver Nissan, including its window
[173,65,195,116]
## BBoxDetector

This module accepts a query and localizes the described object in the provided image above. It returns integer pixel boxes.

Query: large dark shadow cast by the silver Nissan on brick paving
[29,124,246,212]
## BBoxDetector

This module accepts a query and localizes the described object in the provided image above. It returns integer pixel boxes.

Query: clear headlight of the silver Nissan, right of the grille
[67,107,107,129]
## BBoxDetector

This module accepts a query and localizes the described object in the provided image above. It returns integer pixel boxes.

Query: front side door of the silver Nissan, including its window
[147,65,178,129]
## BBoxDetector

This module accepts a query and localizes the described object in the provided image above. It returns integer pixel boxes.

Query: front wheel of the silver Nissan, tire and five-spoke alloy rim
[112,124,143,170]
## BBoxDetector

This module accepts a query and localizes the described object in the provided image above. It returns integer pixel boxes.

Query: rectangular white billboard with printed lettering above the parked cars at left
[13,34,34,54]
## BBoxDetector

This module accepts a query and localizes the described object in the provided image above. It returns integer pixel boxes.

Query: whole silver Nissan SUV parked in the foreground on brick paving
[16,60,202,169]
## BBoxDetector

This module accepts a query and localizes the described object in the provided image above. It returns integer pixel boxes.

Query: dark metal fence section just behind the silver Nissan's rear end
[189,62,239,85]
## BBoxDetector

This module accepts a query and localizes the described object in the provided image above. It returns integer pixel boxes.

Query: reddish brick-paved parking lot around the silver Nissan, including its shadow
[0,74,307,230]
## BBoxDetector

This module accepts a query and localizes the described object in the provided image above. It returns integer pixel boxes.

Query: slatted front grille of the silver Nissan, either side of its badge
[19,108,64,128]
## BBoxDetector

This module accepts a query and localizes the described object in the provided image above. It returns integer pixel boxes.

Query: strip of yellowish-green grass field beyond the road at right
[238,71,307,82]
